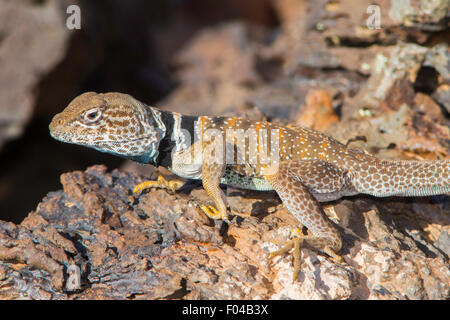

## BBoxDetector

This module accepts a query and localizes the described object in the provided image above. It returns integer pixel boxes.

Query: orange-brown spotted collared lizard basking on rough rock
[49,92,450,279]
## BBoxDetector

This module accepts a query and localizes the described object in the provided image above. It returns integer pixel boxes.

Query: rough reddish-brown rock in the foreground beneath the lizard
[0,166,450,299]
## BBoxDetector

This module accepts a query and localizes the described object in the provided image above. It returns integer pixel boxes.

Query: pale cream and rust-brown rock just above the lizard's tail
[329,44,450,159]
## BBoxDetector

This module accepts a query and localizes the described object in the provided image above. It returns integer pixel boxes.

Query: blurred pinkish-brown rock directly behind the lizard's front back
[161,23,261,114]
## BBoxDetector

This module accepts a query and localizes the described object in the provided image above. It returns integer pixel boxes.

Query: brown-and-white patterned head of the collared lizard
[49,92,165,163]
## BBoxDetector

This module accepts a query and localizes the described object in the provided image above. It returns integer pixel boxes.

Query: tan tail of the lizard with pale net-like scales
[352,159,450,197]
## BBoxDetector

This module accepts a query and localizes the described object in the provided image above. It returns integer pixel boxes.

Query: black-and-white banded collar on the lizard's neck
[149,110,198,168]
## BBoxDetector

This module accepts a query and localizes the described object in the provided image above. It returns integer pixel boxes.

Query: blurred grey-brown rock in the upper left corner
[0,0,69,148]
